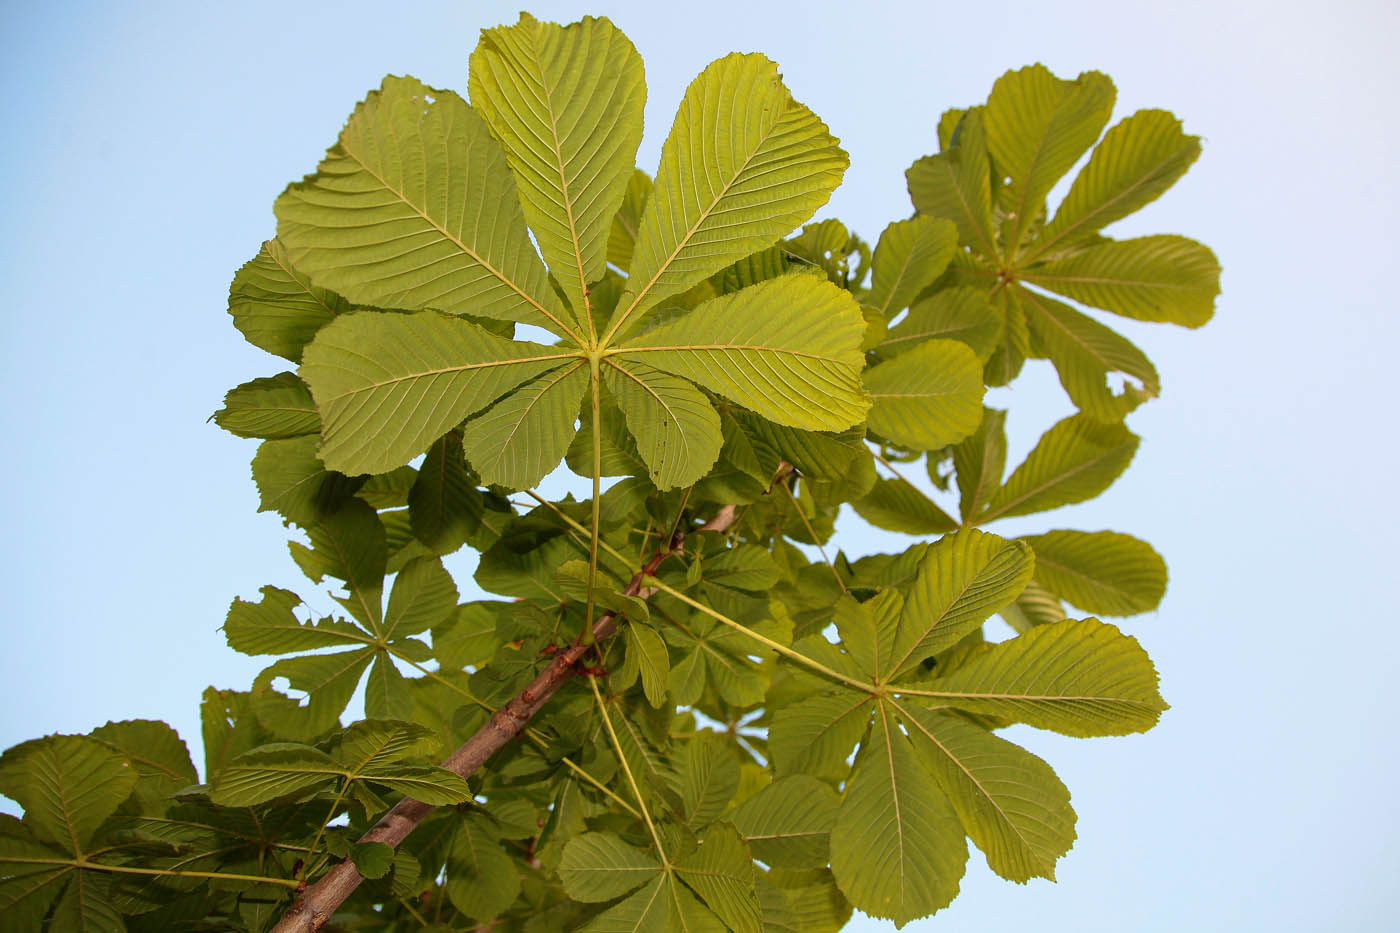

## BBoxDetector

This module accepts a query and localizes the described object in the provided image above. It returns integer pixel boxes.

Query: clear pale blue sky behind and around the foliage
[0,0,1400,932]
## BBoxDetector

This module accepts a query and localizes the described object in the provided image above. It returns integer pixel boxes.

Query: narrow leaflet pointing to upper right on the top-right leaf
[1022,111,1201,263]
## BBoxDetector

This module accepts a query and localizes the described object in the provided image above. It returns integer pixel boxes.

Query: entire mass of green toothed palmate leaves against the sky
[0,14,1218,933]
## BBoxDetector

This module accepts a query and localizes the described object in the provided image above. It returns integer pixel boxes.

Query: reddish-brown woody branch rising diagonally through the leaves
[272,490,761,933]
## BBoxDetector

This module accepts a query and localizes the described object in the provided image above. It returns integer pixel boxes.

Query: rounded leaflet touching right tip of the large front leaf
[864,340,983,450]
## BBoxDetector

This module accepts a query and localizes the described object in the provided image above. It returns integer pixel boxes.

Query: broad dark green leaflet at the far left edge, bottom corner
[4,735,139,855]
